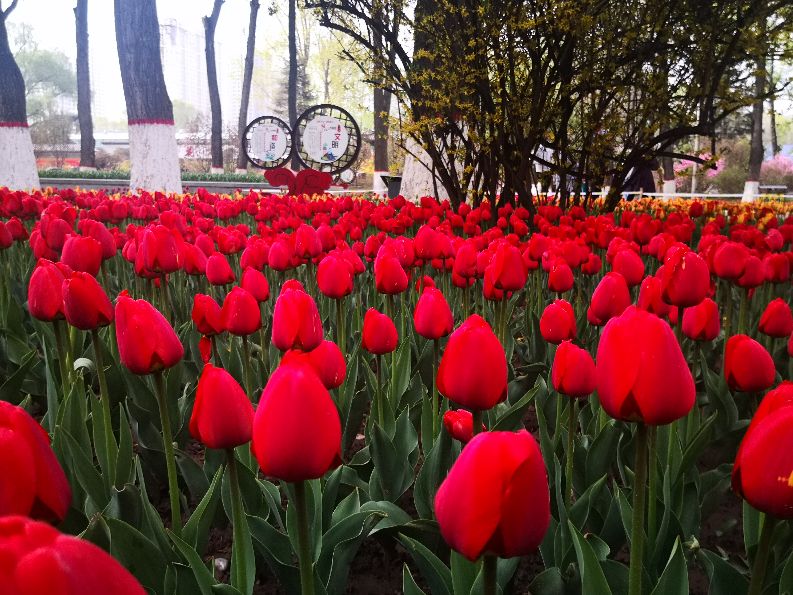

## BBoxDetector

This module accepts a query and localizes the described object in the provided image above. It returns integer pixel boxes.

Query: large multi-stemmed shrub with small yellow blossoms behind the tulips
[306,0,791,209]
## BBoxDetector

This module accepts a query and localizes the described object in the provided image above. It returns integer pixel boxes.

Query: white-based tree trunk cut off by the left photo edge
[0,2,39,190]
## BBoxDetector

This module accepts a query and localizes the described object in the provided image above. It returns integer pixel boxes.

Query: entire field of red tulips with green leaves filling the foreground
[0,189,793,595]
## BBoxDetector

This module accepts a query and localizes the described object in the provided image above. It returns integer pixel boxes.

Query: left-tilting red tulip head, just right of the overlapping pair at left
[116,292,184,374]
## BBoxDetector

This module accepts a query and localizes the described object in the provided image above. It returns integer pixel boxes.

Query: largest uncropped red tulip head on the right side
[596,306,695,425]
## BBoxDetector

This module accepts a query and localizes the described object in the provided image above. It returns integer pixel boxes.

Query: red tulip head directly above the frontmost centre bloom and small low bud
[437,314,507,410]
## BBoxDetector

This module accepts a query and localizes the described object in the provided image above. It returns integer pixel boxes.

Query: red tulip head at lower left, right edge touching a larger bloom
[190,364,253,449]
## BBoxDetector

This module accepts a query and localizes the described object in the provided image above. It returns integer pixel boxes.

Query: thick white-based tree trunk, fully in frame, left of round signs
[114,0,182,192]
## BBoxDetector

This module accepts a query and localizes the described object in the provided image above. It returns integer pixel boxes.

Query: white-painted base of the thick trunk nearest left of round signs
[129,123,182,192]
